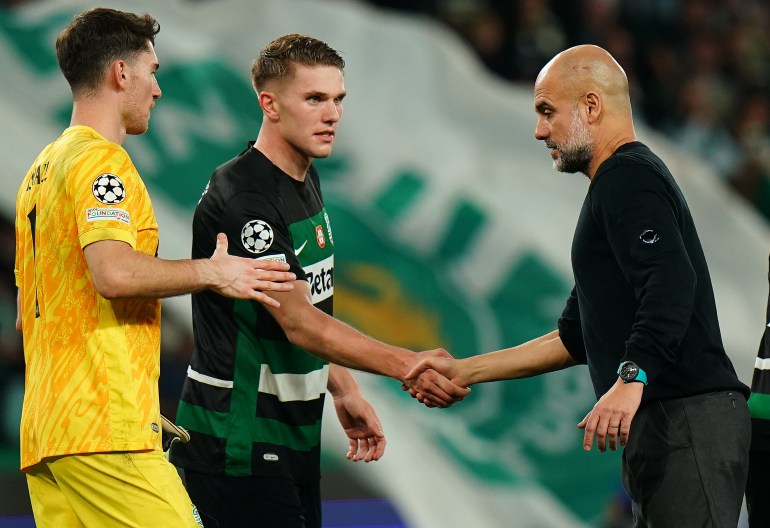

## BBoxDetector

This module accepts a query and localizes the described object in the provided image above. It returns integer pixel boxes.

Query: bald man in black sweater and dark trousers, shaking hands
[407,46,751,528]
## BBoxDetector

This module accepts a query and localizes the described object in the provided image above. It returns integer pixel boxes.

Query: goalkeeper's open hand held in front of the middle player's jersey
[210,233,297,308]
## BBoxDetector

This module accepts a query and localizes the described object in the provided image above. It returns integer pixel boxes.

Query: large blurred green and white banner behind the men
[0,0,770,528]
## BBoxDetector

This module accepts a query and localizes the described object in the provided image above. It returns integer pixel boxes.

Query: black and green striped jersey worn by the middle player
[171,142,334,483]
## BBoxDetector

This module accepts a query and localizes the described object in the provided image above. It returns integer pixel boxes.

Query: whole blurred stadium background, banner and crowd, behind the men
[0,0,770,528]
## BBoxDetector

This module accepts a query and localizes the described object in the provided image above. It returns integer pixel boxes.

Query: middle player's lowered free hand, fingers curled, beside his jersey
[334,393,387,462]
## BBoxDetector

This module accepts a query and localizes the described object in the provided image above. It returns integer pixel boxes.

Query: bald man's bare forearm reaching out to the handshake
[458,330,577,385]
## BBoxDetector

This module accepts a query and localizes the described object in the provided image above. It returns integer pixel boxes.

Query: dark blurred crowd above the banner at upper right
[367,0,770,219]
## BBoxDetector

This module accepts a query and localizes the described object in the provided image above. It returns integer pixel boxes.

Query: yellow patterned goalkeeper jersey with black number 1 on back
[14,126,160,470]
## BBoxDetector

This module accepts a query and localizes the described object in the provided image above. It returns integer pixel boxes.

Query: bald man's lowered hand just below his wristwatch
[578,378,644,453]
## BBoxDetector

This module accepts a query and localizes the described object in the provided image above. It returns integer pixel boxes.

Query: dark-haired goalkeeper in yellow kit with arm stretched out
[14,8,295,528]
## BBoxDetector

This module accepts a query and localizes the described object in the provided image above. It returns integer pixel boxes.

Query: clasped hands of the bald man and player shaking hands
[402,348,471,408]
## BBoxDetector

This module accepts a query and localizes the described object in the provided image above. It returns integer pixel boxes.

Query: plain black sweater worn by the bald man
[559,142,749,401]
